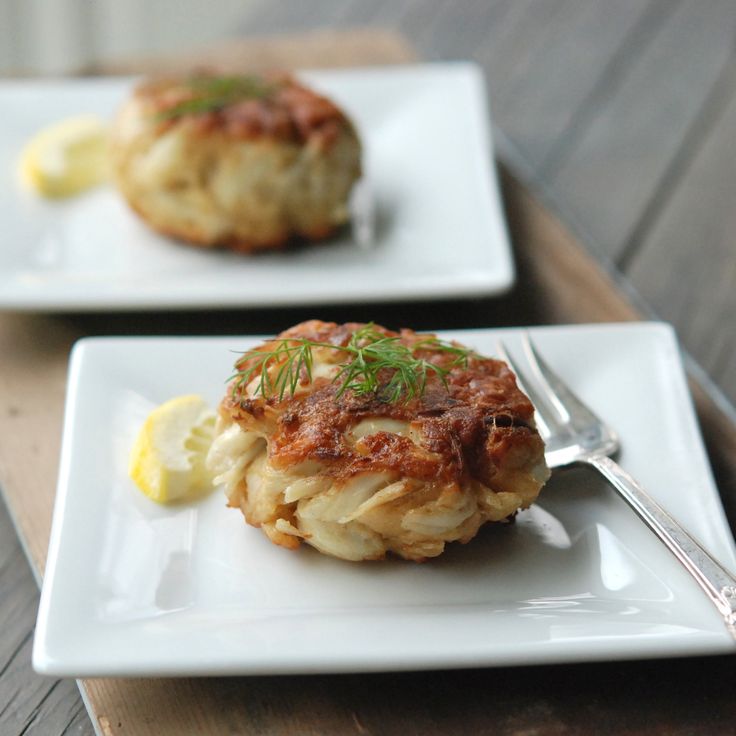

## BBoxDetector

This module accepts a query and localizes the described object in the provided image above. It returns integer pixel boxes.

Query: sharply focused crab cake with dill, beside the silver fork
[208,320,549,561]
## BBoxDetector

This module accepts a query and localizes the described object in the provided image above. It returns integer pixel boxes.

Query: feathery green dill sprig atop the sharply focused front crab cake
[228,323,475,404]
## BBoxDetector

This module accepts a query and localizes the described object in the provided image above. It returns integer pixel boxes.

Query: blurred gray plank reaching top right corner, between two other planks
[544,0,736,262]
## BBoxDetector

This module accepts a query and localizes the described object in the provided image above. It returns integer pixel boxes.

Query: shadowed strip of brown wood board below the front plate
[67,657,736,736]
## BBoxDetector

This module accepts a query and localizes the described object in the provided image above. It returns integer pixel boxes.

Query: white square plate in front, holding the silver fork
[33,323,736,677]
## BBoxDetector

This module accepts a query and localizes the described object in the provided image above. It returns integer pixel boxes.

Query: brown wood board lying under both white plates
[0,32,736,736]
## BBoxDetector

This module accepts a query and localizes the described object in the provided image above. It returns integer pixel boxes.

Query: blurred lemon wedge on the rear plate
[20,115,108,197]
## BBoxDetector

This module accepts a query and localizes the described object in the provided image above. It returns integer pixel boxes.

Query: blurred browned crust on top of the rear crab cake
[135,74,352,146]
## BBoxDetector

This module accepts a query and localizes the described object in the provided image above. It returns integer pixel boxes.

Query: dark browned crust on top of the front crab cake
[221,320,543,485]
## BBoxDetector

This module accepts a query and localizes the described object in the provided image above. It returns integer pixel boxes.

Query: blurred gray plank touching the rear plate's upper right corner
[472,0,665,170]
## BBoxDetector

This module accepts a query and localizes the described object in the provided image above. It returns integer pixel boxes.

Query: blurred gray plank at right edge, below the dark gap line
[629,62,736,408]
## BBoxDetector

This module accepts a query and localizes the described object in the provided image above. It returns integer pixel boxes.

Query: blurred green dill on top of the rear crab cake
[159,75,277,120]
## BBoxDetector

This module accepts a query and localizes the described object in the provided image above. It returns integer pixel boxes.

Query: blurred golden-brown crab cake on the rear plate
[110,75,361,251]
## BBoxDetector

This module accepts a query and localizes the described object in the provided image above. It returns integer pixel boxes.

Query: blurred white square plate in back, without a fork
[0,62,514,311]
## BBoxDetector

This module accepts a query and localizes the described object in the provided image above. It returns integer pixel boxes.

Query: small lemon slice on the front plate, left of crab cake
[128,395,215,503]
